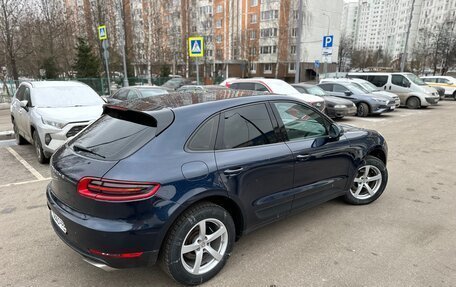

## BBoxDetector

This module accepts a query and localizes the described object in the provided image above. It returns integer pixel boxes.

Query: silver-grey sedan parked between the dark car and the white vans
[318,81,396,117]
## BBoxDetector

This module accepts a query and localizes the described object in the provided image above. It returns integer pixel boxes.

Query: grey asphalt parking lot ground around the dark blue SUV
[0,101,456,286]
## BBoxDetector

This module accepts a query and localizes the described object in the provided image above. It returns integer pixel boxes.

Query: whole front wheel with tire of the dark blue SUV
[344,156,388,205]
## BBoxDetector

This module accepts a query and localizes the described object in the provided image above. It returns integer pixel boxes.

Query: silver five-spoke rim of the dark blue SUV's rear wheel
[181,218,228,275]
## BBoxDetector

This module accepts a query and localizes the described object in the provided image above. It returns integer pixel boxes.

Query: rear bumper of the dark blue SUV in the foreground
[46,187,161,269]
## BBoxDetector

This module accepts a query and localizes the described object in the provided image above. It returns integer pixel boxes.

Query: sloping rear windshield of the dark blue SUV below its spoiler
[70,110,174,160]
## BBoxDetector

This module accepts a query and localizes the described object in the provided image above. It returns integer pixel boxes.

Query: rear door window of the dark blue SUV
[217,104,278,149]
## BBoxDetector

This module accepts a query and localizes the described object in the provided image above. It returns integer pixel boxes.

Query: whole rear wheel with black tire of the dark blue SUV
[159,202,236,285]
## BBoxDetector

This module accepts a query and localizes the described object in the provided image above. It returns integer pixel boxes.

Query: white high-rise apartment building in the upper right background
[341,0,456,63]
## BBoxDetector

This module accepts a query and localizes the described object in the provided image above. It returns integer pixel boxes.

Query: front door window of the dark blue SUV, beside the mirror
[274,102,328,141]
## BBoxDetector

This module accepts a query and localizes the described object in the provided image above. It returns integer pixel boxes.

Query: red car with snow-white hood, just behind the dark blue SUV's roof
[226,78,325,111]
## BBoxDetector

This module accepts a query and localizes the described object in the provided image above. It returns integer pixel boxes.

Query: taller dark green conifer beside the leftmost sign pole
[73,38,100,78]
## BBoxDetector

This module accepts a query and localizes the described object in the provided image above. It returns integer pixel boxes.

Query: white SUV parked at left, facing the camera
[11,81,105,163]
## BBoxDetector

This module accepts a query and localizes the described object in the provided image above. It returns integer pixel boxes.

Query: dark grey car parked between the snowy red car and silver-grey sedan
[292,83,356,119]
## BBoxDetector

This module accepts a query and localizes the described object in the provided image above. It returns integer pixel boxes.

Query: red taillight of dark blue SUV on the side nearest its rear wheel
[78,177,160,202]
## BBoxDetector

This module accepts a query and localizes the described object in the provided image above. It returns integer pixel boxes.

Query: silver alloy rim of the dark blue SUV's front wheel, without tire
[350,165,383,199]
